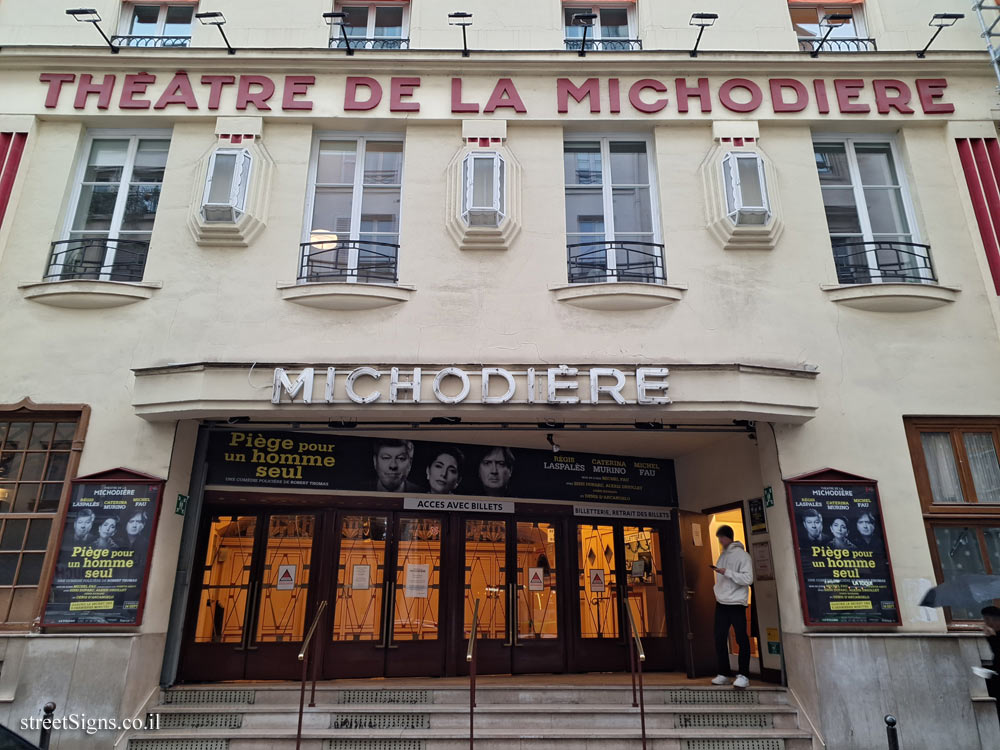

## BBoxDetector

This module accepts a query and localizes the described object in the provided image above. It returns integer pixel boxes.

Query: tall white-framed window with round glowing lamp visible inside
[299,137,403,284]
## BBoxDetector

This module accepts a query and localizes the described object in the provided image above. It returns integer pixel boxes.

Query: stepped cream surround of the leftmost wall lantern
[187,123,274,247]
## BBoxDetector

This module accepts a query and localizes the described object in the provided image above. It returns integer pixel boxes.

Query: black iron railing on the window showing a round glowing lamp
[299,240,399,284]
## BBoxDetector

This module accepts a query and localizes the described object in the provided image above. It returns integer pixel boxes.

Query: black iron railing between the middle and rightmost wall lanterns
[566,241,667,284]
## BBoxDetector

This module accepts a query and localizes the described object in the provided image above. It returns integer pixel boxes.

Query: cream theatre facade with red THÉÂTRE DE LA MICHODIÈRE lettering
[0,0,1000,748]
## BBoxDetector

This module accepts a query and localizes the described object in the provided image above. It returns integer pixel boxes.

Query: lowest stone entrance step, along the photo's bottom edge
[128,726,812,750]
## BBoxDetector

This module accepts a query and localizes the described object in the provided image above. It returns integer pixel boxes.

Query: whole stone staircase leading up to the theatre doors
[118,674,813,750]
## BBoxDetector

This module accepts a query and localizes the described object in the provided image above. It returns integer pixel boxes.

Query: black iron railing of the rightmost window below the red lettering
[833,238,937,284]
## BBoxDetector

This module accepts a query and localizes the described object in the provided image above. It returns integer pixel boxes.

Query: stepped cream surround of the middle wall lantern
[445,131,521,250]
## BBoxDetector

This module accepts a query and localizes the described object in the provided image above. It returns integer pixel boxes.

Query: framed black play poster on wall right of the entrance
[785,469,900,627]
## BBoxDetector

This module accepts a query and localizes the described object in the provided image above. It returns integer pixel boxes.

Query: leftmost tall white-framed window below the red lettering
[45,134,170,281]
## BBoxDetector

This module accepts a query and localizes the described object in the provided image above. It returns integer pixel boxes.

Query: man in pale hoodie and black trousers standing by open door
[712,526,753,688]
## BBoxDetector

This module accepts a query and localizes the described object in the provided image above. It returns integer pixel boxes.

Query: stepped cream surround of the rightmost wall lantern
[699,136,785,250]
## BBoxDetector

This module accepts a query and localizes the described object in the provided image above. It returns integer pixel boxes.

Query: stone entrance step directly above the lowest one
[145,704,798,729]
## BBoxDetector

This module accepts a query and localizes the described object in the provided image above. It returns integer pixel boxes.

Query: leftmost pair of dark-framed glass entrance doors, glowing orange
[181,512,317,681]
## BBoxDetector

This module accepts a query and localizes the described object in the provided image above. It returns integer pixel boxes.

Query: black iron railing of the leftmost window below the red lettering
[42,237,149,281]
